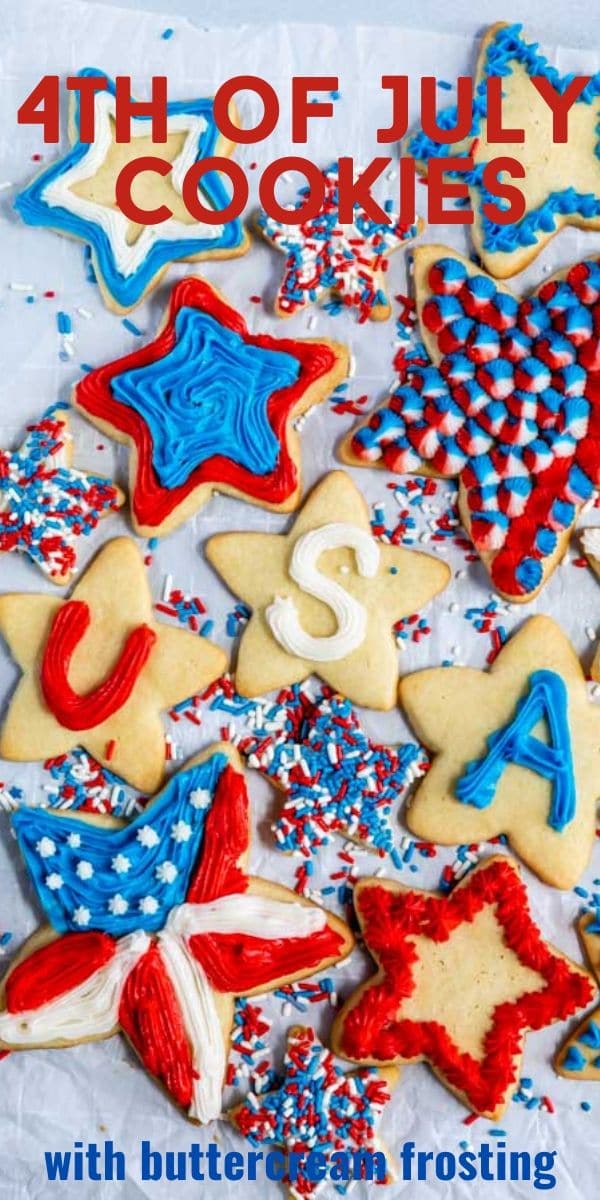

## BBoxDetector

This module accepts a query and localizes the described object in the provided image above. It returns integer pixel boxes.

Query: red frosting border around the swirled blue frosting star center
[74,277,336,527]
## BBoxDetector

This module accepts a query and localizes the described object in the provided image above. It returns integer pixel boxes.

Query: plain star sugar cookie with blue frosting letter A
[400,617,600,888]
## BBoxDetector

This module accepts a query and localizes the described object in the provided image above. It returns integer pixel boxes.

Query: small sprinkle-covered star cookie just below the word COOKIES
[258,163,420,322]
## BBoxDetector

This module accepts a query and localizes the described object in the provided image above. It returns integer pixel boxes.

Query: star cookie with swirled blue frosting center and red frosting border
[73,277,348,536]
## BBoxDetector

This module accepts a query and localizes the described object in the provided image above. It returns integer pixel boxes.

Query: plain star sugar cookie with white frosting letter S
[206,470,450,708]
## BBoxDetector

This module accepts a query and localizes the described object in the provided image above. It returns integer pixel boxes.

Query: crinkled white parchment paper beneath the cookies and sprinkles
[0,0,600,1200]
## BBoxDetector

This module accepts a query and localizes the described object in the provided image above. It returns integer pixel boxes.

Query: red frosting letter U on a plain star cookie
[40,600,156,730]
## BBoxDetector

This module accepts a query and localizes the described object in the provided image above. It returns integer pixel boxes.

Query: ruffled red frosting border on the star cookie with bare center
[338,859,594,1116]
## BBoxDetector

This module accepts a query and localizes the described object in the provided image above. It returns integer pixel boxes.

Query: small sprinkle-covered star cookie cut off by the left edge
[0,404,125,584]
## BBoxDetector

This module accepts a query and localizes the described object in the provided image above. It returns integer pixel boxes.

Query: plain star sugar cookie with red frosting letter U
[0,538,227,792]
